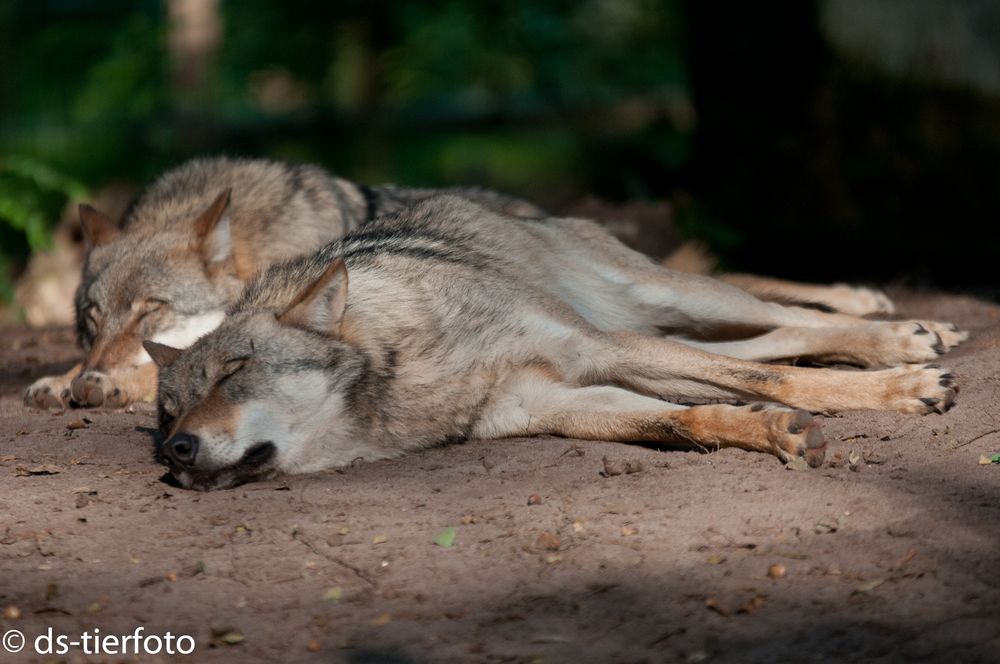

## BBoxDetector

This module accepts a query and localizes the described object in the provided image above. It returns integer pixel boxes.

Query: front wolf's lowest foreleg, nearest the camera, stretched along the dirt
[473,373,826,467]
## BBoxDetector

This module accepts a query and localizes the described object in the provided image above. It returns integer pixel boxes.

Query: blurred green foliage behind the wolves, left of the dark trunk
[0,0,692,300]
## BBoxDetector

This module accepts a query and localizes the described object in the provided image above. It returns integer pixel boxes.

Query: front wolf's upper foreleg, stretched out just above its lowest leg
[566,332,956,413]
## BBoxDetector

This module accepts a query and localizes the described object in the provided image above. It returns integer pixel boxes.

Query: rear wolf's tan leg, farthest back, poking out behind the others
[718,274,896,316]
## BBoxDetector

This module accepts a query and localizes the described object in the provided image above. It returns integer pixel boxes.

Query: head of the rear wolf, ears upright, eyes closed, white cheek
[76,190,241,384]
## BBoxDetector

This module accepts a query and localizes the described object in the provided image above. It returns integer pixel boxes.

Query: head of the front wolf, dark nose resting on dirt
[145,259,369,490]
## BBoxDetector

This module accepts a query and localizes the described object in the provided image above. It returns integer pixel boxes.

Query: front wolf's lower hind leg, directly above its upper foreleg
[675,322,947,368]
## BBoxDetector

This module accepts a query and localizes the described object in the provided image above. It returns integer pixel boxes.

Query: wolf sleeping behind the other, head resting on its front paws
[24,157,542,408]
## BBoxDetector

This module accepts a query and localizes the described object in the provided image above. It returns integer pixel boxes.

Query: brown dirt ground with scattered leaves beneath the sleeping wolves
[0,294,1000,662]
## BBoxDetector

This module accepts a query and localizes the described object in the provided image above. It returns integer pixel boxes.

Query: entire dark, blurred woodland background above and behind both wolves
[0,0,1000,306]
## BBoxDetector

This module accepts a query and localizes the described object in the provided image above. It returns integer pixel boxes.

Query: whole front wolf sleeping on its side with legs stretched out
[145,196,967,490]
